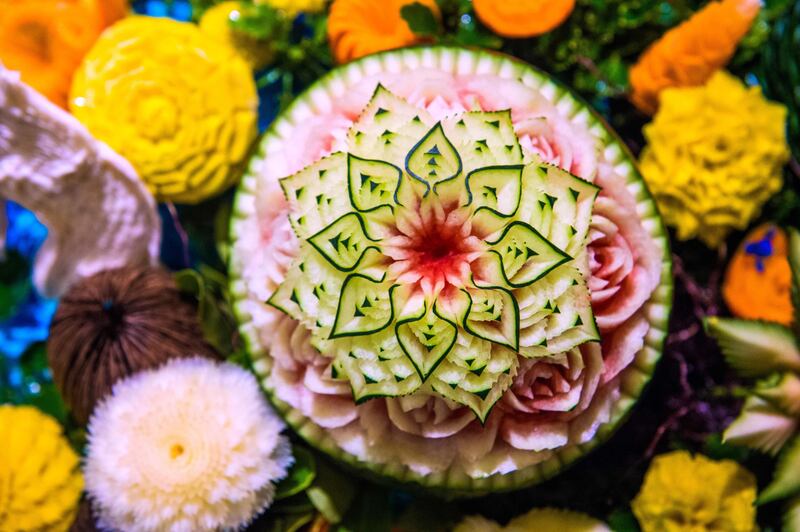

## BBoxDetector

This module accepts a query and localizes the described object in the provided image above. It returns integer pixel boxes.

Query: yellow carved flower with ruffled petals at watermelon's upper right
[640,71,789,247]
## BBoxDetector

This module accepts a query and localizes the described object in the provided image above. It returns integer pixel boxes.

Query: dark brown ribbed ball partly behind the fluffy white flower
[47,268,217,424]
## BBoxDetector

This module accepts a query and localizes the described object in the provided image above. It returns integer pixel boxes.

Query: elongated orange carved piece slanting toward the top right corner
[629,0,761,114]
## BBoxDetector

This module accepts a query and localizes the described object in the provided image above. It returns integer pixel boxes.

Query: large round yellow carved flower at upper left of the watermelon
[70,17,258,203]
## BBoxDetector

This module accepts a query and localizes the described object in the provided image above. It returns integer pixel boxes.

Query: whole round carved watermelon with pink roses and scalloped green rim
[231,48,671,493]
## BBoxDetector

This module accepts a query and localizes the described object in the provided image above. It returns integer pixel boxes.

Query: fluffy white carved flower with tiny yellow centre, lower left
[84,358,293,532]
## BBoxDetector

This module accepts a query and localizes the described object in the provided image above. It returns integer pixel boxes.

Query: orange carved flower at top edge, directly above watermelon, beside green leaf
[328,0,440,63]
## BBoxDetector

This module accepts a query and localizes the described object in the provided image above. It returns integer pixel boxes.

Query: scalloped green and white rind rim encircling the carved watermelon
[228,46,673,497]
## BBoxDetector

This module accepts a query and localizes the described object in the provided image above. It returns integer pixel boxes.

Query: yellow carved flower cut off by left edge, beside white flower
[0,405,83,532]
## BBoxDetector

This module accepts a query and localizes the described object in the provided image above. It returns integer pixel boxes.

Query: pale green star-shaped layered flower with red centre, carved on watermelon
[269,86,599,421]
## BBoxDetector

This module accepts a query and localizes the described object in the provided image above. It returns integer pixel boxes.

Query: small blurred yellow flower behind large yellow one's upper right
[200,1,273,70]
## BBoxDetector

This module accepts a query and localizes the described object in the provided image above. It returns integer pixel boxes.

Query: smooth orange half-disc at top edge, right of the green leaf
[472,0,575,37]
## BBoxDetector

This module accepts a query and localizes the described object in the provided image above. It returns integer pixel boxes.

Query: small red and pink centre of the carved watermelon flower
[384,204,485,293]
